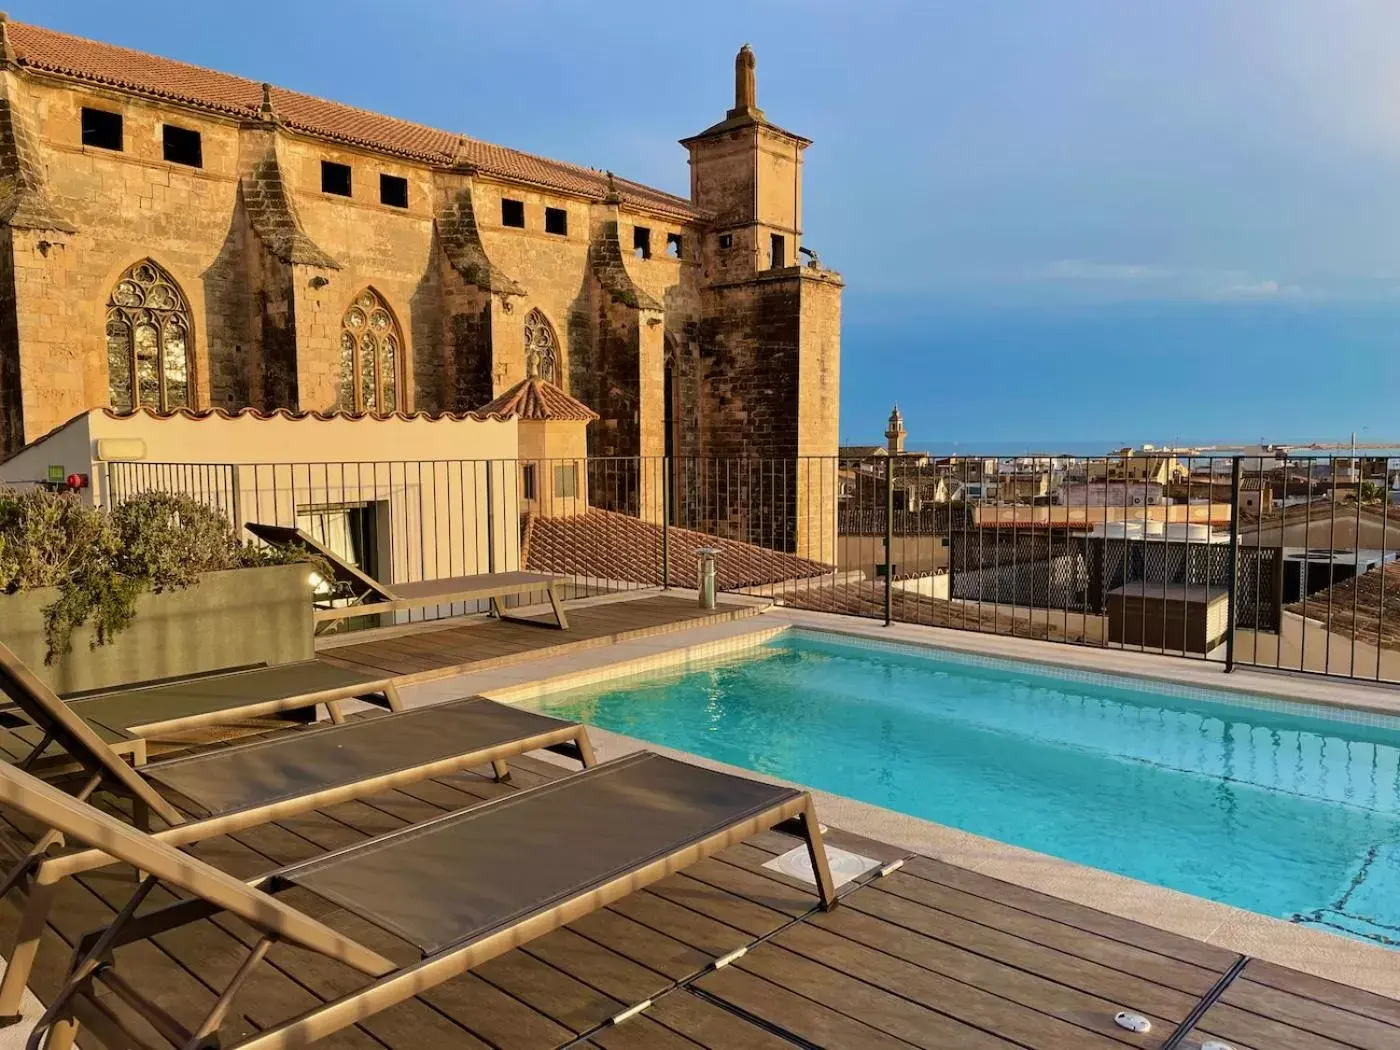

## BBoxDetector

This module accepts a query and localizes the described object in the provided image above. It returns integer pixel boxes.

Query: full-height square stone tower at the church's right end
[680,45,841,560]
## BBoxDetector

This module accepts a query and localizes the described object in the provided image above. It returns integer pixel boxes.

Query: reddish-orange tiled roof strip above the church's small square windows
[7,21,707,218]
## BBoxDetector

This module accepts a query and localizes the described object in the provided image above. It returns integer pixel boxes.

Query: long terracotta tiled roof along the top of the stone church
[7,22,706,220]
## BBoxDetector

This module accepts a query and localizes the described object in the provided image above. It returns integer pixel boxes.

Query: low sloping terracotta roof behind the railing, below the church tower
[524,508,834,591]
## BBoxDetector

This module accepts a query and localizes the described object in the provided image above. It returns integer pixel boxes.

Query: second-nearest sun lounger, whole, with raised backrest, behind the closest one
[0,645,594,1019]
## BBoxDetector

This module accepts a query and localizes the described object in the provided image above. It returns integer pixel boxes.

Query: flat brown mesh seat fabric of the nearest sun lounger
[279,752,802,955]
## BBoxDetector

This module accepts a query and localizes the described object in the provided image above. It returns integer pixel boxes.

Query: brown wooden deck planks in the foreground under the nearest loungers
[0,759,1400,1050]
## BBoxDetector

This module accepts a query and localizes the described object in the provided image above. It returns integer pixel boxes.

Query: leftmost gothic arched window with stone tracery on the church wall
[106,259,195,412]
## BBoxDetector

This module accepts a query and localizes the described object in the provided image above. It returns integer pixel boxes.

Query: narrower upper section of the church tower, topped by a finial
[680,43,812,280]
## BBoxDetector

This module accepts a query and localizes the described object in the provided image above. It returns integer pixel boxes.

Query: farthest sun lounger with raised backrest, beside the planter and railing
[245,521,568,634]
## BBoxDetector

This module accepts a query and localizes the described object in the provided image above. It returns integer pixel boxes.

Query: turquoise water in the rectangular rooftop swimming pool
[539,633,1400,946]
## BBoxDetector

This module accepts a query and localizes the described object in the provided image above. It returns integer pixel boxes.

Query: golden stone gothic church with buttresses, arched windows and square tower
[0,17,841,546]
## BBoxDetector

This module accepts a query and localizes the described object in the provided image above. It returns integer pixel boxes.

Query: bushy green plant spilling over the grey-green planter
[0,490,311,664]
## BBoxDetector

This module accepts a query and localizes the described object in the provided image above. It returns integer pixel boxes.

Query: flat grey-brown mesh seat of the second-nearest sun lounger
[141,697,571,815]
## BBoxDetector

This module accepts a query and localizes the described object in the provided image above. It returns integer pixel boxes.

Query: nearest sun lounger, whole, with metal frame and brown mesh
[0,752,836,1050]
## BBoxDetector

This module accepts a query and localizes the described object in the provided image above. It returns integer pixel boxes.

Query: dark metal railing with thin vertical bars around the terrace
[104,452,1400,682]
